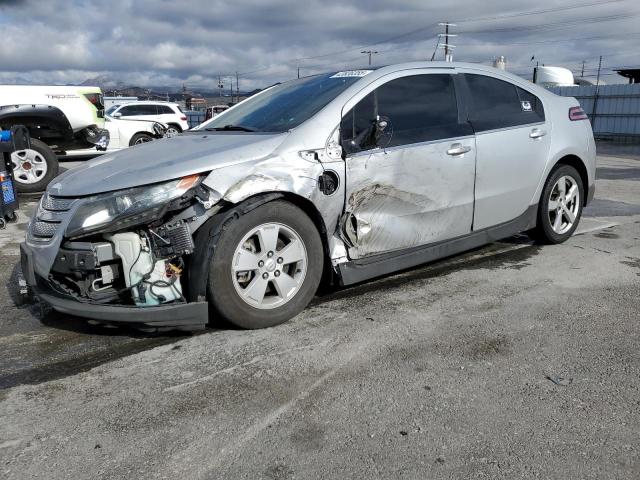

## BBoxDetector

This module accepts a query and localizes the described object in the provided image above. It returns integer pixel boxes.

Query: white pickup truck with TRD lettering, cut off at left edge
[0,85,109,192]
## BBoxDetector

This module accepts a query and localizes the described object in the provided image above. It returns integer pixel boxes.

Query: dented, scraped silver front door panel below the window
[342,136,475,258]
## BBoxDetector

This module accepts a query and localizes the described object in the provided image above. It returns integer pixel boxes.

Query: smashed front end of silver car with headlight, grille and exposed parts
[22,175,220,330]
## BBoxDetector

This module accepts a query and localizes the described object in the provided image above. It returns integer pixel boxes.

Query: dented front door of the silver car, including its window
[340,74,475,259]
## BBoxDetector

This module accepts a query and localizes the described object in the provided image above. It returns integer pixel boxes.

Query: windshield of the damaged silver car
[198,71,369,132]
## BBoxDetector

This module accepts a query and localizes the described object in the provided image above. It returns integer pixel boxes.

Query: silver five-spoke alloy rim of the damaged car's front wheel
[231,223,308,309]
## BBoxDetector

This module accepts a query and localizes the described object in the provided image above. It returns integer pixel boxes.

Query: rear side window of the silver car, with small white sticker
[464,74,544,132]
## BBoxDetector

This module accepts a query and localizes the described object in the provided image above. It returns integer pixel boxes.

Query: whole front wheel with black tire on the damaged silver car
[208,200,324,329]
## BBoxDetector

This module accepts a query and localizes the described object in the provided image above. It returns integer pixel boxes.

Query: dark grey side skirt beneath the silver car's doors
[338,205,538,286]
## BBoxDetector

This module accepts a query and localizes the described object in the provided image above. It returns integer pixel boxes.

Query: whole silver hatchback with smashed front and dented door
[22,62,595,329]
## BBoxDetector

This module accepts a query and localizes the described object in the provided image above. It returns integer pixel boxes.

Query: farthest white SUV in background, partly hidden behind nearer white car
[108,101,189,137]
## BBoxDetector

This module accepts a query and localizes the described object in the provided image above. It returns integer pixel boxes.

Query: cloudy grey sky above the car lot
[0,0,640,90]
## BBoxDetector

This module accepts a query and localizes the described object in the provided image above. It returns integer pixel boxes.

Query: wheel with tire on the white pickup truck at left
[11,138,58,193]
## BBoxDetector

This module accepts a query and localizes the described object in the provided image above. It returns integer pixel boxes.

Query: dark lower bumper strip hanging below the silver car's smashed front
[20,243,209,331]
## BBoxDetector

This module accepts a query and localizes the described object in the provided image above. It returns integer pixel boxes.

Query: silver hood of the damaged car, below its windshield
[47,131,287,197]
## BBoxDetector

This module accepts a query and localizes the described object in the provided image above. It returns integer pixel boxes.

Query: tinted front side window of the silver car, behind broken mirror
[340,74,471,153]
